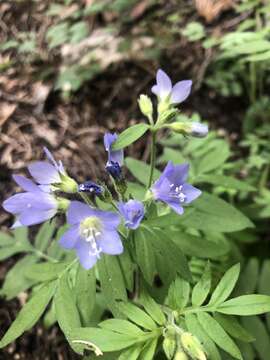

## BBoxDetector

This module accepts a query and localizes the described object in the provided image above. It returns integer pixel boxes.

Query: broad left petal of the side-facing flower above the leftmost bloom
[28,161,61,185]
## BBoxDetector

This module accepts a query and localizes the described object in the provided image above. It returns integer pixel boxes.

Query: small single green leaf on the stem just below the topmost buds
[112,124,150,150]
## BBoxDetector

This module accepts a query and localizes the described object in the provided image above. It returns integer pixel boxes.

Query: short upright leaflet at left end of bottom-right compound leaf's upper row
[166,278,190,311]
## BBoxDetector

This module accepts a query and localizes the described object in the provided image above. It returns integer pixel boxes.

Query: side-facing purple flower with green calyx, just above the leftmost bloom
[28,148,78,193]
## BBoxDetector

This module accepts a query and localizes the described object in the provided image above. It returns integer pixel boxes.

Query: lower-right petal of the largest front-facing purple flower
[97,230,124,255]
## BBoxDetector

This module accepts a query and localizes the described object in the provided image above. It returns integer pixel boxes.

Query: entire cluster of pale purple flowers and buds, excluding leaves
[3,70,205,269]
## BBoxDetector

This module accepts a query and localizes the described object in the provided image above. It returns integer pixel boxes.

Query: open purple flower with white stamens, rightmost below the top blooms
[151,161,201,215]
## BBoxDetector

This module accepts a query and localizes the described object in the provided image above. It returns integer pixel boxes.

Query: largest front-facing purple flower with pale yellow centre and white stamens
[60,201,123,269]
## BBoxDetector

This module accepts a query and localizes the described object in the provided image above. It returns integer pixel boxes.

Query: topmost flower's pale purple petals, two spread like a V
[152,69,192,104]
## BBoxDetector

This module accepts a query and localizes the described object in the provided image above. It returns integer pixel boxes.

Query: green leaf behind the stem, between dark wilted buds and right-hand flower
[125,157,160,185]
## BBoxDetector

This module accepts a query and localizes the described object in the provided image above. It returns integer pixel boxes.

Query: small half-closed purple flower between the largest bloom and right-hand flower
[118,200,144,229]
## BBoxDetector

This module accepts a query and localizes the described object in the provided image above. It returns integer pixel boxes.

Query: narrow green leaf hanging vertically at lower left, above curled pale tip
[54,271,81,352]
